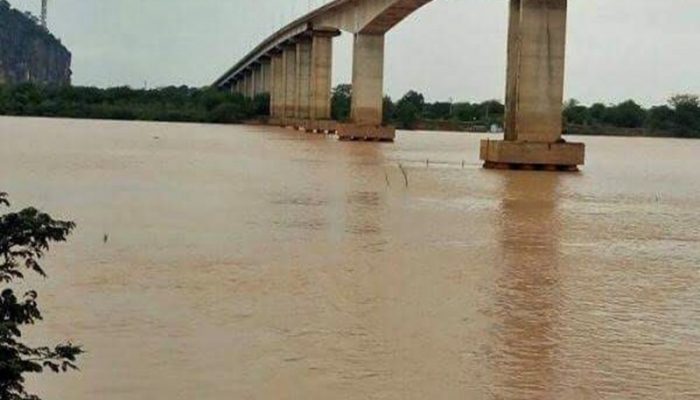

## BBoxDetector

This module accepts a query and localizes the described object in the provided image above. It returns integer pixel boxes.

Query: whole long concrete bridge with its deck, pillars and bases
[214,0,585,170]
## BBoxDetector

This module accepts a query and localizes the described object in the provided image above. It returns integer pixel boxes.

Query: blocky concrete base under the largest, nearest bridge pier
[481,140,586,171]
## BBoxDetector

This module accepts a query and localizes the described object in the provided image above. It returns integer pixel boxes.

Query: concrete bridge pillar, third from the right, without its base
[309,32,337,119]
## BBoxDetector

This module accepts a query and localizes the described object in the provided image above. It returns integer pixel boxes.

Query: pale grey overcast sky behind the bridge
[10,0,700,105]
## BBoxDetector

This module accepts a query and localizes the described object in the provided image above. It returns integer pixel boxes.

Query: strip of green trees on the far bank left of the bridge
[0,83,269,123]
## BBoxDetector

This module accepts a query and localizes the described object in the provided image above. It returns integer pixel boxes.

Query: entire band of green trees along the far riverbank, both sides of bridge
[0,84,700,138]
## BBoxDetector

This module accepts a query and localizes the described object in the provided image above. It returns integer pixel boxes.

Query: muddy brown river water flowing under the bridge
[0,118,700,400]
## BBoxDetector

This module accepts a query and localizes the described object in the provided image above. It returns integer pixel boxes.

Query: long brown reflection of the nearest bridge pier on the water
[493,172,560,399]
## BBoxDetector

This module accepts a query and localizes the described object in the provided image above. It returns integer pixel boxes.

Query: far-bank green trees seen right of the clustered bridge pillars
[332,85,700,138]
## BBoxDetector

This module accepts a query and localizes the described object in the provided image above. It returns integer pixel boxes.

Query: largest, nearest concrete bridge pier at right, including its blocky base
[481,0,585,170]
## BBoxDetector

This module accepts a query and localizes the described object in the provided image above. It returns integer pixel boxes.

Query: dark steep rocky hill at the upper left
[0,0,71,85]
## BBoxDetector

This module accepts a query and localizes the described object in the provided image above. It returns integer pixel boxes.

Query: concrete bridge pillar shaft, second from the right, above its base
[350,33,384,125]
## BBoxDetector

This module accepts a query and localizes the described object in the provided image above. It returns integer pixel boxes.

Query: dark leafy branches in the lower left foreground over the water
[0,193,83,400]
